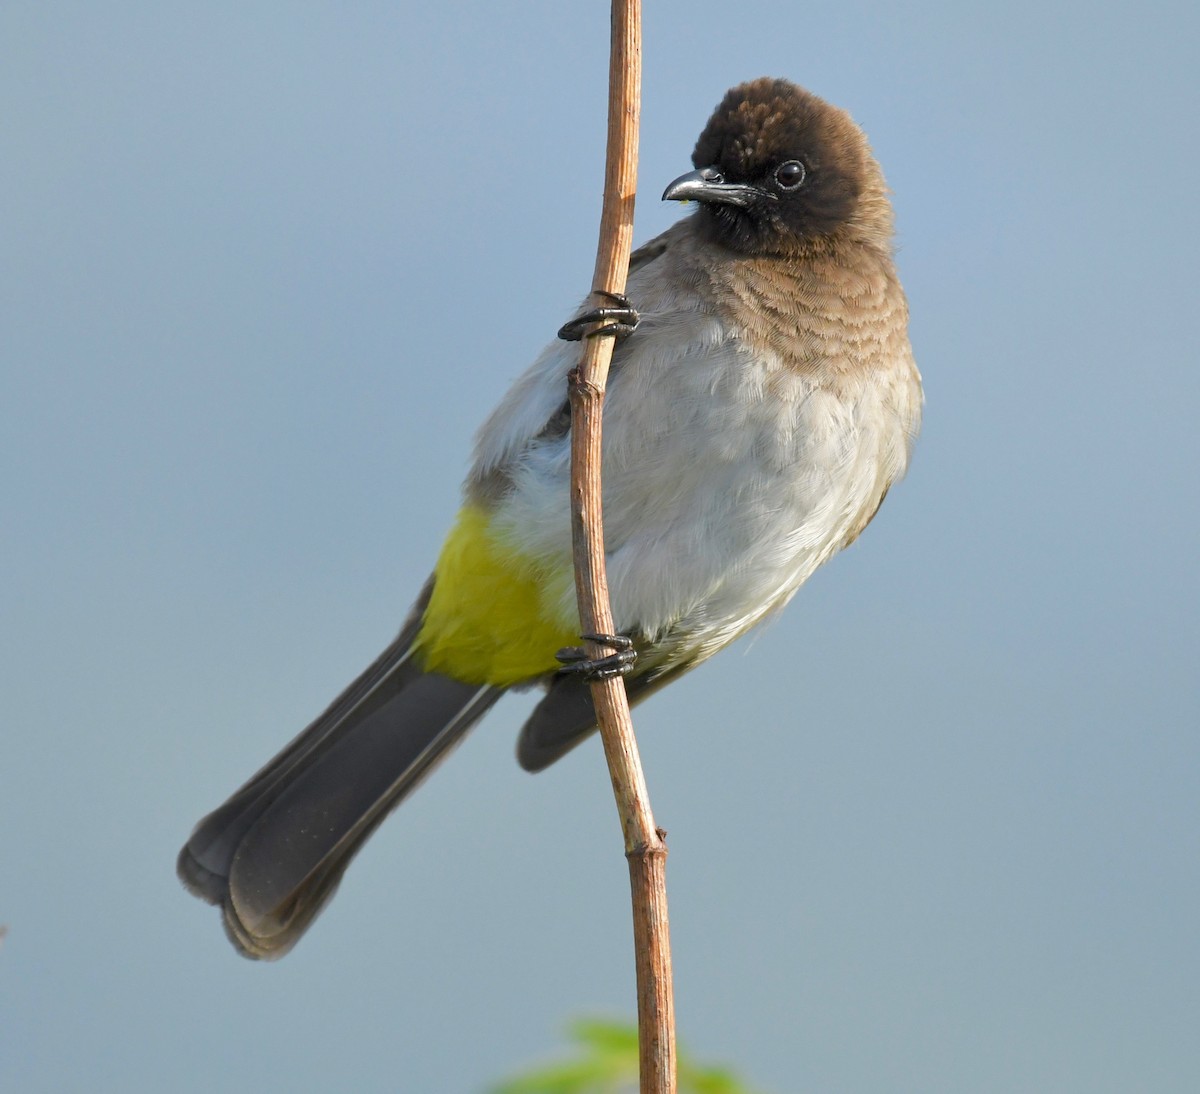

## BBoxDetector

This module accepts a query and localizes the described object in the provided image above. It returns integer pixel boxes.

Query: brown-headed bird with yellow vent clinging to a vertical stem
[178,78,923,958]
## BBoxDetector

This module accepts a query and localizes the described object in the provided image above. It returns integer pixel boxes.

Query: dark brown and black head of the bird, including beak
[664,79,871,254]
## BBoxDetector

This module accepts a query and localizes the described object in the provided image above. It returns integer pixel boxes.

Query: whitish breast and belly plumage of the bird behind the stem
[475,243,920,657]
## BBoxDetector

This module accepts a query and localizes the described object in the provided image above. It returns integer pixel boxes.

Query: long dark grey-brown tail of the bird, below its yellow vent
[178,626,502,958]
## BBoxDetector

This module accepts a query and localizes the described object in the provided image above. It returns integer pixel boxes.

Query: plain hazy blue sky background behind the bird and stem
[0,0,1200,1094]
